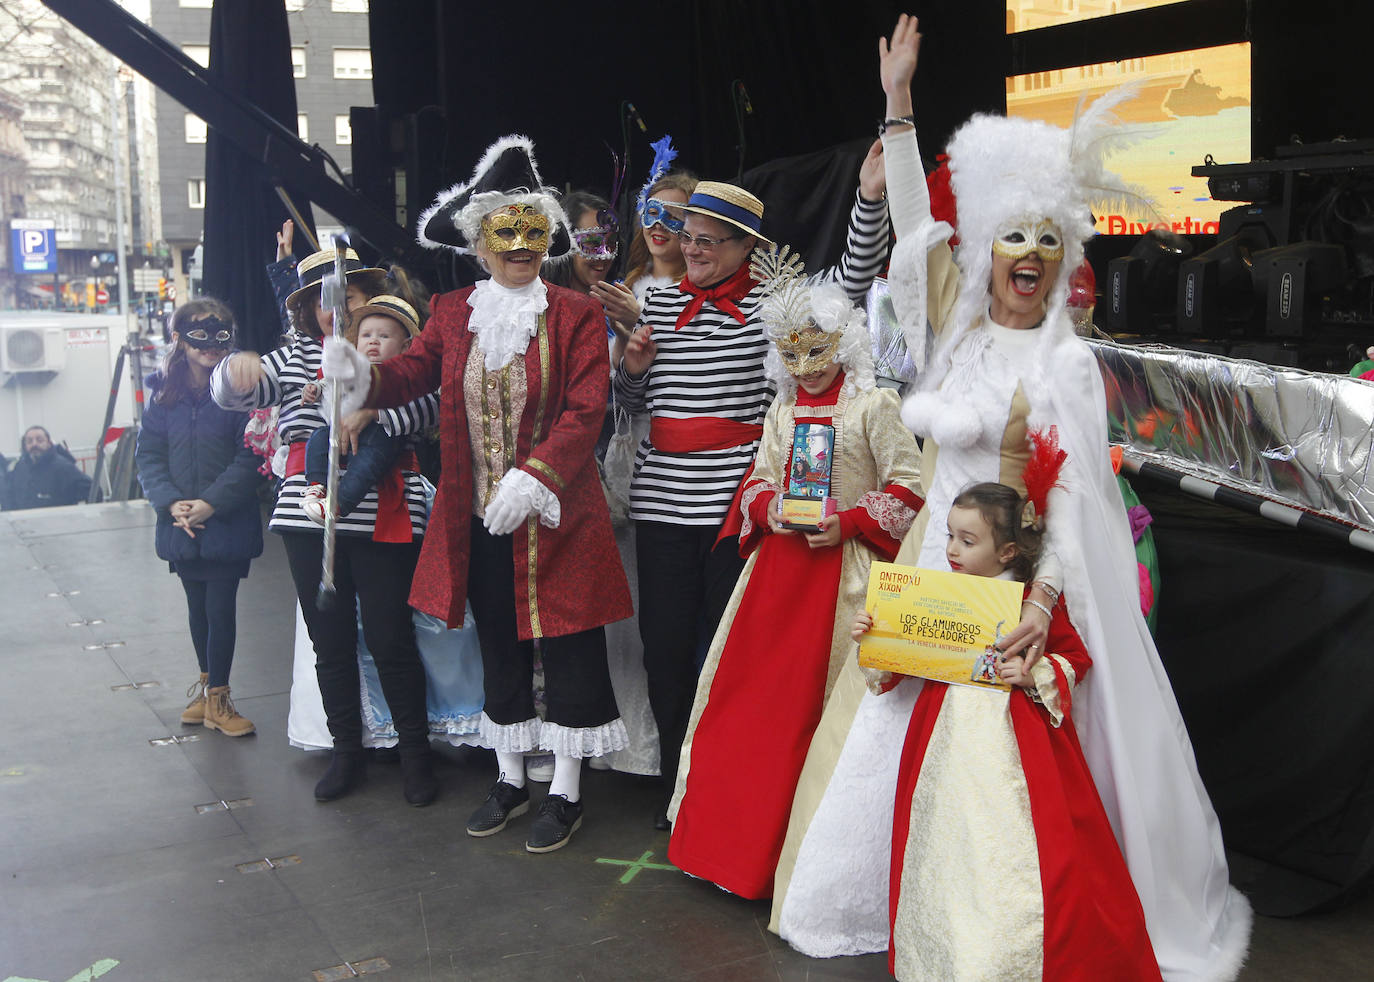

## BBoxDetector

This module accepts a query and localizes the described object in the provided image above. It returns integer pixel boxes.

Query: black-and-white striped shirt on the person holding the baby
[210,334,438,537]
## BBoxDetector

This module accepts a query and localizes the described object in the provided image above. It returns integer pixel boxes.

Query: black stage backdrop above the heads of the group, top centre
[365,0,1007,289]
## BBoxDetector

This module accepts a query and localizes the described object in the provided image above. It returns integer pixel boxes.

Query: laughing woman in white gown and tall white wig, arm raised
[769,15,1252,982]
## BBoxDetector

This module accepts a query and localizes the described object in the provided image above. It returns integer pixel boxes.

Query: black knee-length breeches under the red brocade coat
[467,518,620,728]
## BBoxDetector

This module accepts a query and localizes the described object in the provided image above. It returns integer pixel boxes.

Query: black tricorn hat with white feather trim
[416,135,572,258]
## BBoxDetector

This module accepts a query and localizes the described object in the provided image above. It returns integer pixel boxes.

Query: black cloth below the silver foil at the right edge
[1132,479,1374,916]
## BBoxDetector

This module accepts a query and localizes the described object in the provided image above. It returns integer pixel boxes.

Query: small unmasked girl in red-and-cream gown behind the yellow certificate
[855,482,1160,982]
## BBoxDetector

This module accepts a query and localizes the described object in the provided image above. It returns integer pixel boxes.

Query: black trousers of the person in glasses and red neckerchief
[635,522,745,794]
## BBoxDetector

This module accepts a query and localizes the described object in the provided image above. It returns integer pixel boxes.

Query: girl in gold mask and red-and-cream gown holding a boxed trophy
[668,250,922,898]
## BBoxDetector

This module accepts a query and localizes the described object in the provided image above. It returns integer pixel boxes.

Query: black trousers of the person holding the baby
[282,532,429,753]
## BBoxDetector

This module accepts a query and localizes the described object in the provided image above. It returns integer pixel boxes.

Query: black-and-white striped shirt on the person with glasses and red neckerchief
[613,198,888,526]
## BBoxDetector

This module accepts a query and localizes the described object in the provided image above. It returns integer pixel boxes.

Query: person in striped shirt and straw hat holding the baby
[210,249,438,806]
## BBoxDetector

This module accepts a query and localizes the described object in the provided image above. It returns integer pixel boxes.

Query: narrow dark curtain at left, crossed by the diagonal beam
[205,0,313,352]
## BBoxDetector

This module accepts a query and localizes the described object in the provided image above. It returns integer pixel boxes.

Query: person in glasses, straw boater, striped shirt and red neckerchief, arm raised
[611,154,888,830]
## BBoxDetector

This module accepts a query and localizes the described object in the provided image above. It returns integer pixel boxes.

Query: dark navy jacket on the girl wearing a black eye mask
[133,372,262,562]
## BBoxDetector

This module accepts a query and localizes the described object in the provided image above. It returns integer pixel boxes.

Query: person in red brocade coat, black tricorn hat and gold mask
[326,137,631,853]
